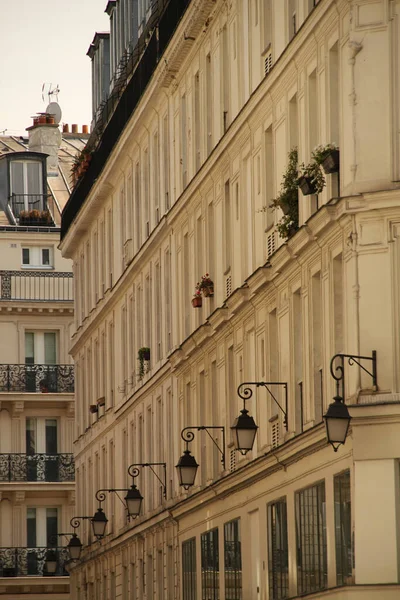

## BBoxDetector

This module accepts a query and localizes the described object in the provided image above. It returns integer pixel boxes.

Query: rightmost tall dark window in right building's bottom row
[333,471,353,585]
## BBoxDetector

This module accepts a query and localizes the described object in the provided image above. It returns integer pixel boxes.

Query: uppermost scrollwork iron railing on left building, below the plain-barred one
[0,365,74,394]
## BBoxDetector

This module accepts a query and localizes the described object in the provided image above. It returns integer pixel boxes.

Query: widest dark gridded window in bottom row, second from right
[296,481,328,594]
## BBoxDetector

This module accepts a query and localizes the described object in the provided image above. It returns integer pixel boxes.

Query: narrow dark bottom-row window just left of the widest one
[268,498,289,600]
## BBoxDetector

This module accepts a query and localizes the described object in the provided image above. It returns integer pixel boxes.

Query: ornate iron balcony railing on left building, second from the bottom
[0,453,75,481]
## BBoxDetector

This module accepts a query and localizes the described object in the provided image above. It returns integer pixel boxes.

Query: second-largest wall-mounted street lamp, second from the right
[231,381,288,456]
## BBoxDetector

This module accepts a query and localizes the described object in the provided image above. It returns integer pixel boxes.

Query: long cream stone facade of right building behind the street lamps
[61,0,400,600]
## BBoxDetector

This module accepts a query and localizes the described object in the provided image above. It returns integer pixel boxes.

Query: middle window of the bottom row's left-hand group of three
[201,529,219,600]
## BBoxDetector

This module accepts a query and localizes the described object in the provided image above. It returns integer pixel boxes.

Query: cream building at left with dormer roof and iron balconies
[0,119,83,600]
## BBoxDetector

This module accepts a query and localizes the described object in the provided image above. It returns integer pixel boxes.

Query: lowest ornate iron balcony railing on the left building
[0,547,69,577]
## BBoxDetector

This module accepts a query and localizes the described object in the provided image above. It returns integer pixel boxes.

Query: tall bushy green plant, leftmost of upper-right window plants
[260,148,299,239]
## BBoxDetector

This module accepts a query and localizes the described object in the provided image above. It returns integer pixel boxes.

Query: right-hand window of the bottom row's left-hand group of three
[224,519,242,600]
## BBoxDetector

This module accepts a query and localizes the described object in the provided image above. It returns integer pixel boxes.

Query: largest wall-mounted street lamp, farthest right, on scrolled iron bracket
[323,350,378,452]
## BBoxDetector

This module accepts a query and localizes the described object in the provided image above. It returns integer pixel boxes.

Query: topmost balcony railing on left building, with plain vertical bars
[0,270,73,302]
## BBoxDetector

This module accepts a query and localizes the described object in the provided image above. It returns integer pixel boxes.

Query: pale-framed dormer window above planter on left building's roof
[10,160,46,218]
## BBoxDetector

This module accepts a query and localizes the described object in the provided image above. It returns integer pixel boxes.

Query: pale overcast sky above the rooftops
[0,0,109,135]
